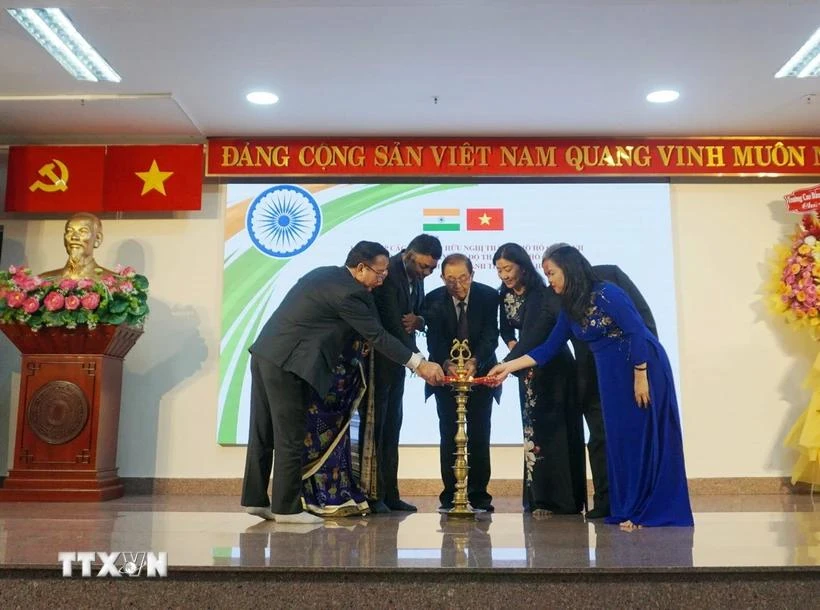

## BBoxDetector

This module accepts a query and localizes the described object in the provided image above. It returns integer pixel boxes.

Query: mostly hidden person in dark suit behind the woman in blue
[541,243,658,519]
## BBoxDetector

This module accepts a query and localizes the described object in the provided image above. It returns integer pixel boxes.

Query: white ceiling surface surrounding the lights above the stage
[0,0,820,144]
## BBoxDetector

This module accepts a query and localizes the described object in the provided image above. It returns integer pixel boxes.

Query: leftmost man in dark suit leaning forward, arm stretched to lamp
[242,241,443,523]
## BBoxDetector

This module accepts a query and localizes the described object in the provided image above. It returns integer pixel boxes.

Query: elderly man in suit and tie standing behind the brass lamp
[423,254,501,511]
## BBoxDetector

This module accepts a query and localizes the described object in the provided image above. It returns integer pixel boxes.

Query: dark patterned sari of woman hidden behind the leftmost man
[302,336,370,517]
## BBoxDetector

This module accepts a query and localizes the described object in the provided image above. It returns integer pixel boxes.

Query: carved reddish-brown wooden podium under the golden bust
[0,324,142,502]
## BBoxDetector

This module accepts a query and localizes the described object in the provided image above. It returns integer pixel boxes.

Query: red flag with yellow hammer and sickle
[6,146,105,214]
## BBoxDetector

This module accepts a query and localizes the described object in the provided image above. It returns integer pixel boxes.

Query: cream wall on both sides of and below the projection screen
[0,182,816,479]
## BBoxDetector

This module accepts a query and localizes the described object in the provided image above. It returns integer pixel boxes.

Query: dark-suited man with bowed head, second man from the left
[370,234,441,513]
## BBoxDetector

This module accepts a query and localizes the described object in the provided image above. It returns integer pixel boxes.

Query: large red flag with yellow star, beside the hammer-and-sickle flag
[104,144,203,212]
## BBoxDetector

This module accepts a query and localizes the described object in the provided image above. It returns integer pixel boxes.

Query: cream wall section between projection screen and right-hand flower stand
[672,182,817,477]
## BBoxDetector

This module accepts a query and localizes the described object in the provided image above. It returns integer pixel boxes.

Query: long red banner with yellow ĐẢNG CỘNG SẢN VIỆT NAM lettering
[207,137,820,177]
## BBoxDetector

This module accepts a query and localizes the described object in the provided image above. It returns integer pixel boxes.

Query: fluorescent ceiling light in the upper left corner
[7,8,122,83]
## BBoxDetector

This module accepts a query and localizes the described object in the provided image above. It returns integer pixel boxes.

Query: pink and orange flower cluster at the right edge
[769,213,820,340]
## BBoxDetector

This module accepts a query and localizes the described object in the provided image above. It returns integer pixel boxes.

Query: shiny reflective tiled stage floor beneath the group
[0,495,820,570]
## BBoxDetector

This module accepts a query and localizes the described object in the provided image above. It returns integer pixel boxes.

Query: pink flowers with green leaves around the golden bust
[0,265,148,331]
